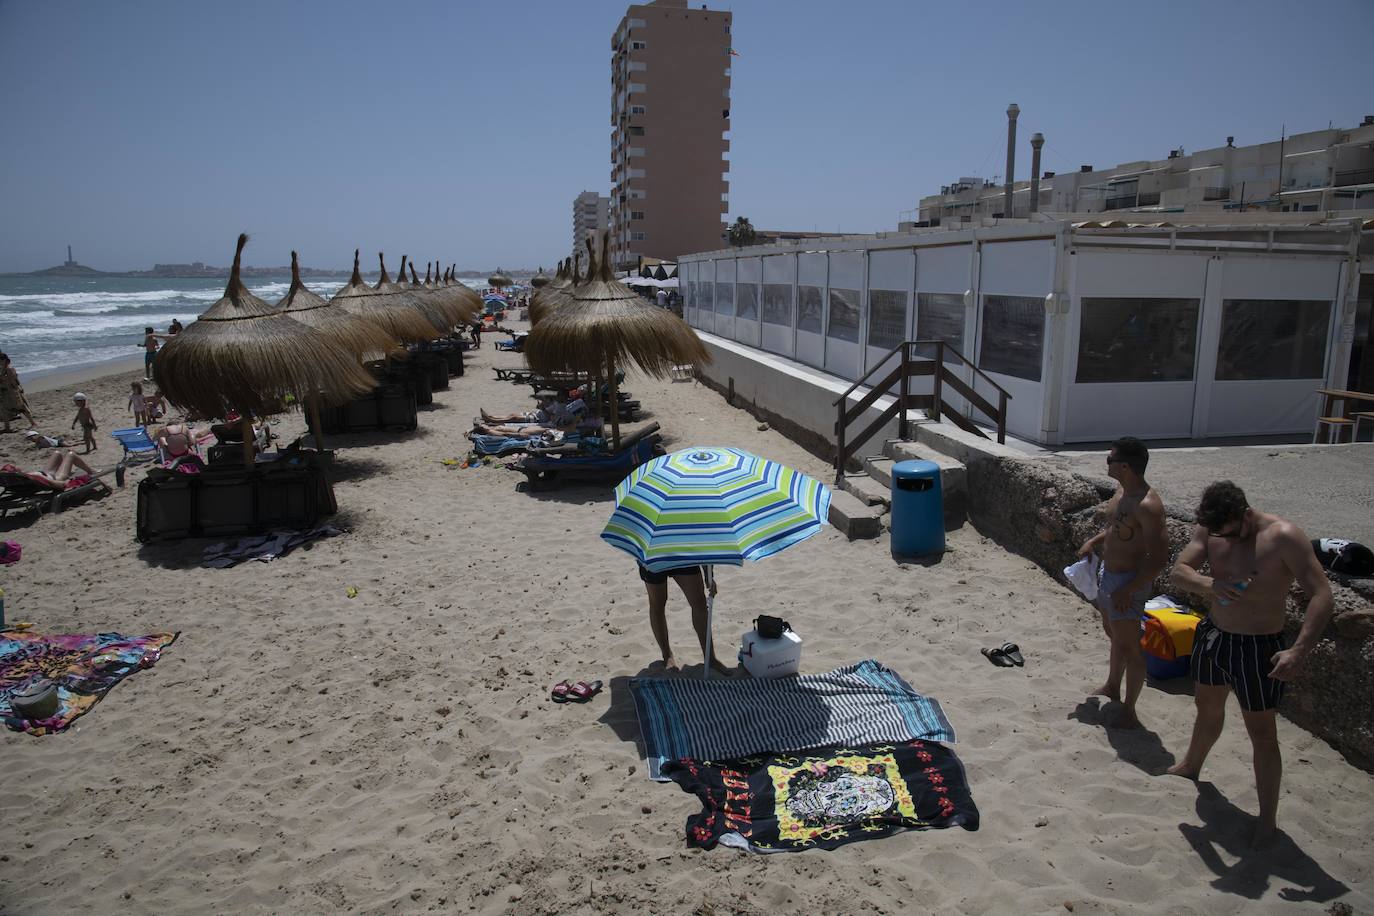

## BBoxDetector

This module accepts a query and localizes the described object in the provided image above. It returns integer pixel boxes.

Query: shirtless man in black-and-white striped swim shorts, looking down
[1169,481,1331,846]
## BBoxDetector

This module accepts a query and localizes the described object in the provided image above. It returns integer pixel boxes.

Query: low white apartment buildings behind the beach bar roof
[899,115,1374,228]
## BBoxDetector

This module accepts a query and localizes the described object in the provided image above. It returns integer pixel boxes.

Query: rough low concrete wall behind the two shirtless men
[961,450,1374,770]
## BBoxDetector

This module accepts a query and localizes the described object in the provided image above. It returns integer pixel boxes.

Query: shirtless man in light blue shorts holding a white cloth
[1079,435,1169,728]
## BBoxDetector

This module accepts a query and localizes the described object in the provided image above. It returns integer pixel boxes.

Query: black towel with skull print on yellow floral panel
[664,742,978,853]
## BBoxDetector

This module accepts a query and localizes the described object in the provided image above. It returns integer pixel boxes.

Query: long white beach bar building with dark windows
[679,213,1374,445]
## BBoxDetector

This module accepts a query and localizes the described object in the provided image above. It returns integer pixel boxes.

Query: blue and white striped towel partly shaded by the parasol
[629,659,955,780]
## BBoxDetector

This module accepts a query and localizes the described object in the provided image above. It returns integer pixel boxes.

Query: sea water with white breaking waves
[0,275,483,379]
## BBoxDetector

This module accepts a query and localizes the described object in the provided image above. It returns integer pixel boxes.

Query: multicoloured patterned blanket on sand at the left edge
[0,630,179,735]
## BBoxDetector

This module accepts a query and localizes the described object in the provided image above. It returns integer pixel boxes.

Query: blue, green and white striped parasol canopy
[602,446,830,573]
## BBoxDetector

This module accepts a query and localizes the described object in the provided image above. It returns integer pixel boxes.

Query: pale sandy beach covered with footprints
[0,334,1374,916]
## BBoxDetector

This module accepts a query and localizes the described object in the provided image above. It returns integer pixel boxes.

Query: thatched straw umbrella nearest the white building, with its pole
[525,233,710,449]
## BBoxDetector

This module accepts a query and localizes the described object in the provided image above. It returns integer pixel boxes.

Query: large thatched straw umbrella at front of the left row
[155,235,372,464]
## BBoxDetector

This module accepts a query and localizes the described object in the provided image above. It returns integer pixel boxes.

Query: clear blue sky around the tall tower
[0,0,1374,272]
